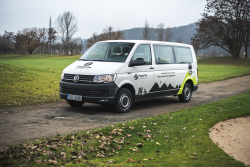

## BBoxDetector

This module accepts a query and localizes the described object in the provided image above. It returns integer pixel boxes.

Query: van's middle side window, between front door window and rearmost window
[154,45,174,64]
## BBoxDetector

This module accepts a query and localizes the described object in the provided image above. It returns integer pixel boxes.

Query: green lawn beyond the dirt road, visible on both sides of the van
[0,54,250,108]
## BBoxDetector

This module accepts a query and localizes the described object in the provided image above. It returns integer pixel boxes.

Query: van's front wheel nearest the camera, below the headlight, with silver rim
[114,88,133,113]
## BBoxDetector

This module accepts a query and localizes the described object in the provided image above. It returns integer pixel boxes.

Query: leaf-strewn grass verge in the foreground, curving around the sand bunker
[0,92,250,167]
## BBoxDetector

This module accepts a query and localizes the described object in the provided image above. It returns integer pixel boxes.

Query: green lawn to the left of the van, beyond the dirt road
[0,55,80,108]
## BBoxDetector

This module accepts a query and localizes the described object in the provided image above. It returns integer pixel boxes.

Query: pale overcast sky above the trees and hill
[0,0,206,39]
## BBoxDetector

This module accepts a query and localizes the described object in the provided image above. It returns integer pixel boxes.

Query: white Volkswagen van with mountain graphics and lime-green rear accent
[60,40,198,113]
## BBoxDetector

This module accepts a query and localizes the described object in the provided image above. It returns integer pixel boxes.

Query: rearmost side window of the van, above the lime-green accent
[174,47,193,63]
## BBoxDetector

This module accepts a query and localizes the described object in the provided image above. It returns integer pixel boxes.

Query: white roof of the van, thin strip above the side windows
[99,40,191,46]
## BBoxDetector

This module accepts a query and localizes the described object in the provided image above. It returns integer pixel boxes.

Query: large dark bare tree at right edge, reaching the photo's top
[191,0,250,58]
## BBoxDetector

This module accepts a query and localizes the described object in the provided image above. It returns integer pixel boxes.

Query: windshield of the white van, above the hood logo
[79,42,135,62]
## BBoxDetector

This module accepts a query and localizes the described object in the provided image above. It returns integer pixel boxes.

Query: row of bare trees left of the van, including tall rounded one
[0,12,84,55]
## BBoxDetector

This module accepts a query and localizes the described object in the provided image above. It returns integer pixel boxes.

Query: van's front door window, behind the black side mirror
[132,45,152,65]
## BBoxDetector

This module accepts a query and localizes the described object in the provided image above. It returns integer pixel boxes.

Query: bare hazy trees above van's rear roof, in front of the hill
[143,20,173,41]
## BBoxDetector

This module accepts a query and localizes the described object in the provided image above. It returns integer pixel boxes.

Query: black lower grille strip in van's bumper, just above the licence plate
[60,87,110,97]
